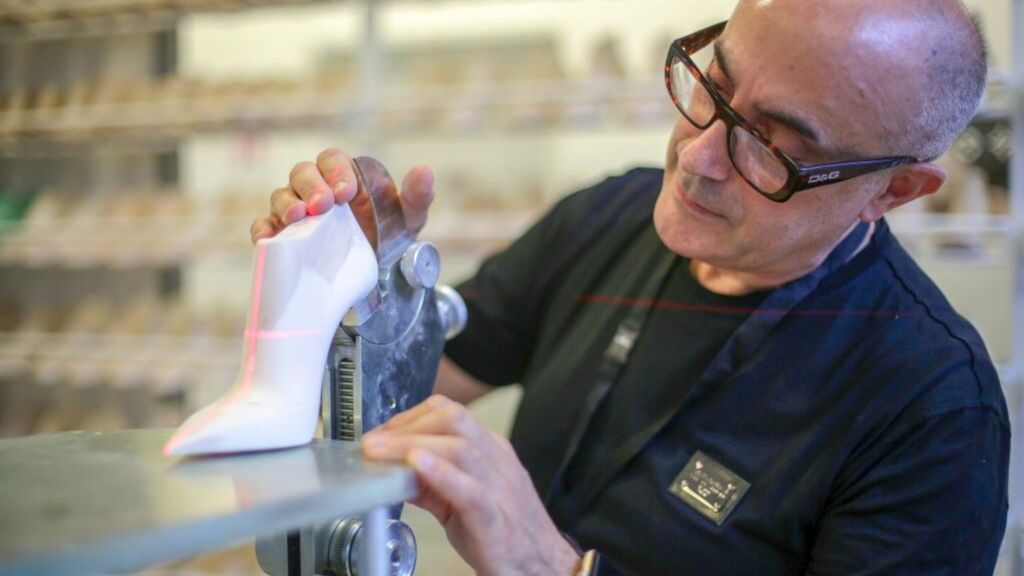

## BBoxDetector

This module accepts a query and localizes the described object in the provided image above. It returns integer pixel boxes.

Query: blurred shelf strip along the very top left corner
[0,0,330,43]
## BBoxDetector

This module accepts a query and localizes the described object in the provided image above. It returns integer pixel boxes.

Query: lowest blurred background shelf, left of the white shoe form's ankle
[0,297,245,436]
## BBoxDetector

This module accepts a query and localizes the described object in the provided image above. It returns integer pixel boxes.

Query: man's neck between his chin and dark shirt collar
[690,222,874,296]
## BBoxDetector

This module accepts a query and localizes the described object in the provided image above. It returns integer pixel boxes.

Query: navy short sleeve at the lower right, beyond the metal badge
[808,407,1010,576]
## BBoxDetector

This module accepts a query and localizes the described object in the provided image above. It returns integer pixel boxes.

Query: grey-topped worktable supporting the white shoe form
[0,430,416,576]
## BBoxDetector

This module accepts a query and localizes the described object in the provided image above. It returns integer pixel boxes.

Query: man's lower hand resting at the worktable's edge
[362,396,580,576]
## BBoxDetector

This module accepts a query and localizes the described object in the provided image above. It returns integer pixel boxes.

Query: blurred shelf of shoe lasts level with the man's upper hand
[0,191,539,270]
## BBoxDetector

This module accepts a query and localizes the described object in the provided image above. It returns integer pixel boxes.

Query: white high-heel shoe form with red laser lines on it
[164,205,377,455]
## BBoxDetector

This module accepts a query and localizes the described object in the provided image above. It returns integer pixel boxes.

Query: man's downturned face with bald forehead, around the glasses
[654,1,898,273]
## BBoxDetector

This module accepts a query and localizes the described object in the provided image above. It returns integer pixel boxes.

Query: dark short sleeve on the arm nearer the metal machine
[444,168,663,385]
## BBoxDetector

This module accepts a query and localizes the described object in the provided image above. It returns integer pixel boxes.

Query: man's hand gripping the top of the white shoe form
[249,148,434,244]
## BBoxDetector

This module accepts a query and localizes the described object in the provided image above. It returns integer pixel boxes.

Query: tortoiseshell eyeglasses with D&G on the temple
[665,22,924,202]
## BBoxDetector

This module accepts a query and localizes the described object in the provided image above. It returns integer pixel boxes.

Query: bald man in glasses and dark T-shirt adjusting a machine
[252,0,1010,576]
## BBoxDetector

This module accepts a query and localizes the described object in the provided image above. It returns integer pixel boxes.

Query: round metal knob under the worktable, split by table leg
[328,518,416,576]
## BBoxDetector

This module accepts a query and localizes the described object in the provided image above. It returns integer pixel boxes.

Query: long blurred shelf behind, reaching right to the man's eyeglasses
[0,79,675,148]
